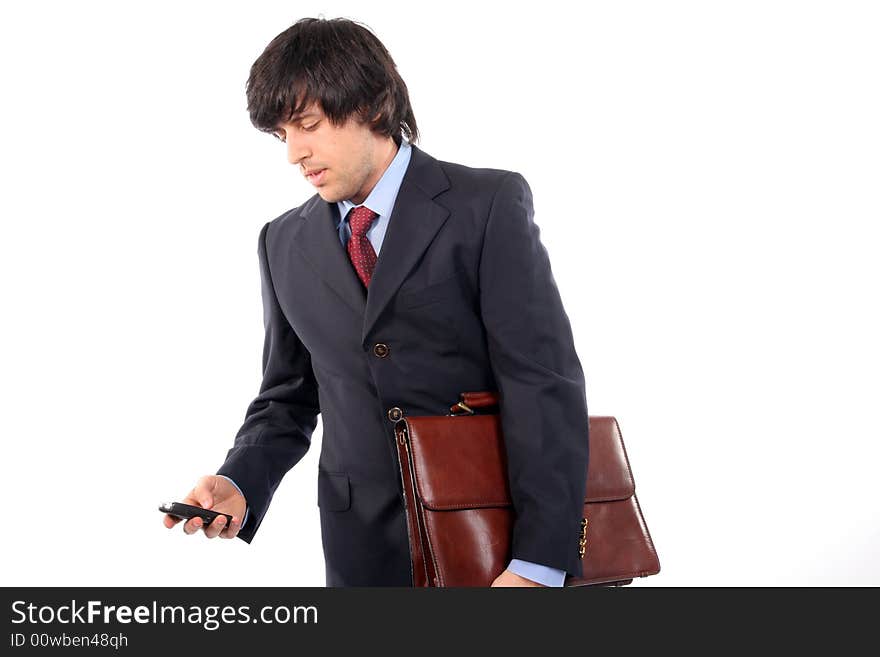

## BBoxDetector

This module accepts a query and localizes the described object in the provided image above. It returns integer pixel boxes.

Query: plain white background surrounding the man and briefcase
[0,0,880,586]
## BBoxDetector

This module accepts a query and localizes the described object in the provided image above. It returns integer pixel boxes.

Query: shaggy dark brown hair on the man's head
[246,18,419,143]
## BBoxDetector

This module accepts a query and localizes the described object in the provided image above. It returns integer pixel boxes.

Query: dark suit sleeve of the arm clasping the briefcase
[479,172,589,576]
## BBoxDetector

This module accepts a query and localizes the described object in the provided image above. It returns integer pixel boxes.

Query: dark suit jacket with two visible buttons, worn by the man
[218,146,589,586]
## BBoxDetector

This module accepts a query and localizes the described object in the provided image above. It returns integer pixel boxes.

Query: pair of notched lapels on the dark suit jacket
[292,146,449,341]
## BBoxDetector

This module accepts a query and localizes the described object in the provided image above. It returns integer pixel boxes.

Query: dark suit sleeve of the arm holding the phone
[217,224,320,543]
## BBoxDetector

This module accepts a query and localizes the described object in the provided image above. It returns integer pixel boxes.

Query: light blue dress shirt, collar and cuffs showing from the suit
[220,139,565,586]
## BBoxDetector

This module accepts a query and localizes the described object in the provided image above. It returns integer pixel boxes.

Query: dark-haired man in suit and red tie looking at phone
[164,19,588,586]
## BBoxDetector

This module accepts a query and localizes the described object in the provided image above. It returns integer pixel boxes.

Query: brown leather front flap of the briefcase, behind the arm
[402,414,635,511]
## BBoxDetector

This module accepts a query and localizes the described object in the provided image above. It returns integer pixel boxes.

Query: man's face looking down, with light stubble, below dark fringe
[275,103,397,205]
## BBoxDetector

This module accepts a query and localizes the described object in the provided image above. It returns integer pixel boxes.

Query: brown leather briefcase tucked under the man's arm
[394,391,660,586]
